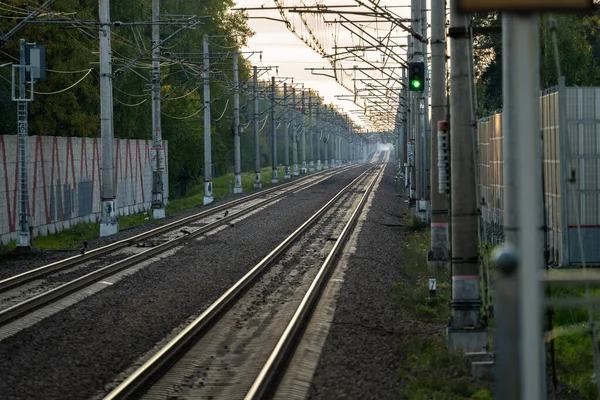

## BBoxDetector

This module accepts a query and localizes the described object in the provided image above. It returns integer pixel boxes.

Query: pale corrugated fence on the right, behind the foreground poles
[477,81,600,265]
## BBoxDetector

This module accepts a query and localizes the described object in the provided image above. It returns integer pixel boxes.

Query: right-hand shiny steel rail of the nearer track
[244,167,384,400]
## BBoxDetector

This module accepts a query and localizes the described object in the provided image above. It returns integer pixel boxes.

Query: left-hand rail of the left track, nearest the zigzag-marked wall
[0,166,354,293]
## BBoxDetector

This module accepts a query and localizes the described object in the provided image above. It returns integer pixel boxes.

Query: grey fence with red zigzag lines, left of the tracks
[0,135,169,244]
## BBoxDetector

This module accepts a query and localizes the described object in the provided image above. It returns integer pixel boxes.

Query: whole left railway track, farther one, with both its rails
[0,161,368,332]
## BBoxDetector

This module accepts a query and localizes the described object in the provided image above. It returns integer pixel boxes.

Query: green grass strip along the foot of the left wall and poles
[0,166,285,253]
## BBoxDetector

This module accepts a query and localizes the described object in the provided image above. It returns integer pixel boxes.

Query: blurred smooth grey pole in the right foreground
[496,14,546,400]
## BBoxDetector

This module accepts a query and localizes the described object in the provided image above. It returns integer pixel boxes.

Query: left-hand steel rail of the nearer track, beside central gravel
[104,166,377,400]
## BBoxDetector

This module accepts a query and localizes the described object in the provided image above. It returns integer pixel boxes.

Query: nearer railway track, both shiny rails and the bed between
[105,161,383,400]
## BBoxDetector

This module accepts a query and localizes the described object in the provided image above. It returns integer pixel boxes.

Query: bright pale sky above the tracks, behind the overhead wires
[237,0,410,127]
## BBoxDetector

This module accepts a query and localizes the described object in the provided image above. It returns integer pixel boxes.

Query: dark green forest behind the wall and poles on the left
[0,0,344,197]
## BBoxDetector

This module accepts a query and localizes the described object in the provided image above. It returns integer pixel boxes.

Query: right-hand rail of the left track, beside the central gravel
[0,164,370,326]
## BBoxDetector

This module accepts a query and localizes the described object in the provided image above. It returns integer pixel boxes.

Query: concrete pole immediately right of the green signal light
[429,0,450,263]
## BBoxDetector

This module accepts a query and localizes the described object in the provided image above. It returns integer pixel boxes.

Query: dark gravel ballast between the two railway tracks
[0,166,367,399]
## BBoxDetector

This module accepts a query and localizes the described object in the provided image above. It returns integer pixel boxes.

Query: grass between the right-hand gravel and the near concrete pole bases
[392,217,492,400]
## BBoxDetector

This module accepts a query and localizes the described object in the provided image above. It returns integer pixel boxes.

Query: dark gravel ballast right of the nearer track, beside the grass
[308,163,406,400]
